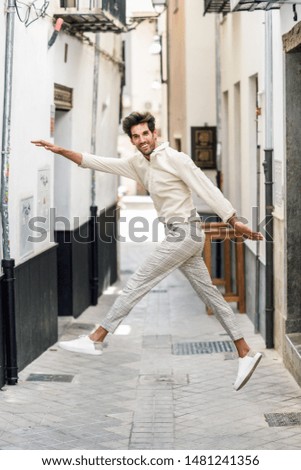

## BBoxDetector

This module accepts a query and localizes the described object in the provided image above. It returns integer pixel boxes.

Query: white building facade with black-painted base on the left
[0,0,125,382]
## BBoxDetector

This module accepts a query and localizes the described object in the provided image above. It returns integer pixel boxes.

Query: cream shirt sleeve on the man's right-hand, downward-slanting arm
[173,153,236,222]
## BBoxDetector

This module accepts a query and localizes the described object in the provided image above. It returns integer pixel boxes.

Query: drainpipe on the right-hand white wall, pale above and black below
[263,10,274,349]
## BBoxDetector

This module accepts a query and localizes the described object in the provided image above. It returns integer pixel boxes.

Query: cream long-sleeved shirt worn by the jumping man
[80,142,235,223]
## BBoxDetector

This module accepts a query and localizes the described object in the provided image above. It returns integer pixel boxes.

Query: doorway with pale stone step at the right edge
[285,40,301,385]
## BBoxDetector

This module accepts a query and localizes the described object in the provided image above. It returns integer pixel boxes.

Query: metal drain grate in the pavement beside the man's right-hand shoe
[172,341,236,356]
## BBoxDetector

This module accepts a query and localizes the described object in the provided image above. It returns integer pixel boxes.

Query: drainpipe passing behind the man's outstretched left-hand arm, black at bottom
[90,33,100,305]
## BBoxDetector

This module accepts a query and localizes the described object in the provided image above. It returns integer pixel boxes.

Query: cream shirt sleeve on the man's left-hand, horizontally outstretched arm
[79,152,137,180]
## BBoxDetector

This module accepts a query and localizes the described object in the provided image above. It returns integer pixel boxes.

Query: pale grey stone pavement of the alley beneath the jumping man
[0,203,301,450]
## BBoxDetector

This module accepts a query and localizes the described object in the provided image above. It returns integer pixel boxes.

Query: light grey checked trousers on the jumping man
[101,222,243,341]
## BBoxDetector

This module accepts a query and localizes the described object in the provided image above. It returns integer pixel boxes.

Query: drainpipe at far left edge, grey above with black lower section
[1,0,18,385]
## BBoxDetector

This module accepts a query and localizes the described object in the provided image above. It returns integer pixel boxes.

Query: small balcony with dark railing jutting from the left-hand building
[53,0,126,33]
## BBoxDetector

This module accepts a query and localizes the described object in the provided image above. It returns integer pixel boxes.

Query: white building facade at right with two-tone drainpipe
[216,2,301,383]
